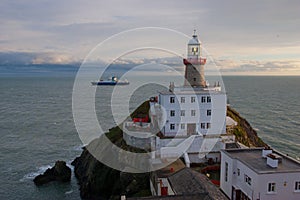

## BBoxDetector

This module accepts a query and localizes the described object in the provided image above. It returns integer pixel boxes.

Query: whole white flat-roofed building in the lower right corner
[220,148,300,200]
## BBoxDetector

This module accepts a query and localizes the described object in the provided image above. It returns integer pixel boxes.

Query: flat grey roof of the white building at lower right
[222,148,300,174]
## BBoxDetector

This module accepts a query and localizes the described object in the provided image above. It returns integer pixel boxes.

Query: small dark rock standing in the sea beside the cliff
[33,161,72,185]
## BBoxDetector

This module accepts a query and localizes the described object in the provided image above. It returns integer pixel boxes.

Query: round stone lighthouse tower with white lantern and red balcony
[183,30,206,88]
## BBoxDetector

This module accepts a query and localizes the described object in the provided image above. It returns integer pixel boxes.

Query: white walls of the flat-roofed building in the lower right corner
[220,152,300,200]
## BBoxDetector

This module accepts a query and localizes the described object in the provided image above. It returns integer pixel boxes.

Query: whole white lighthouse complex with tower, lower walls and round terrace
[123,31,235,166]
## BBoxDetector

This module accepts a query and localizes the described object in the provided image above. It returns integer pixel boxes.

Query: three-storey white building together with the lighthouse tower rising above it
[158,34,227,137]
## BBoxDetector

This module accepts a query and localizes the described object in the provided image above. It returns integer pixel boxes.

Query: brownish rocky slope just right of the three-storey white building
[227,106,268,147]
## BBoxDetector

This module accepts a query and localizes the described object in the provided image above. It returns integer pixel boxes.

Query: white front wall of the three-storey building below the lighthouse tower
[159,92,226,136]
